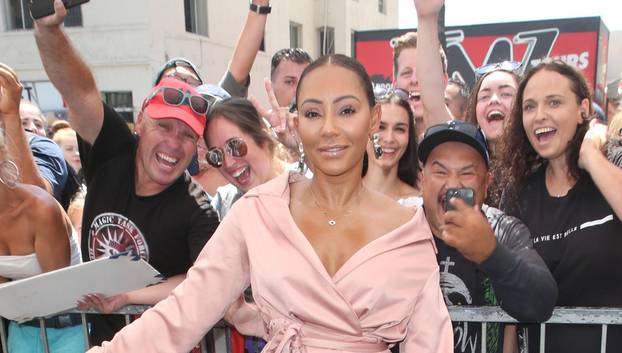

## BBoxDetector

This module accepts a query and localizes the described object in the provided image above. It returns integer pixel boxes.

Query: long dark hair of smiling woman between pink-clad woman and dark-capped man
[363,93,419,187]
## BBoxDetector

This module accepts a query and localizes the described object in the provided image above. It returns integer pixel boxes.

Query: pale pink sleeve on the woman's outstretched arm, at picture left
[89,200,250,353]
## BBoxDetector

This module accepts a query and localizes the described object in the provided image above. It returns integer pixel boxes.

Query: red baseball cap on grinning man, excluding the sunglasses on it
[142,77,206,136]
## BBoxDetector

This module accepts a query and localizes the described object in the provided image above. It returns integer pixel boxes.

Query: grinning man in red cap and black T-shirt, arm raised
[35,0,218,344]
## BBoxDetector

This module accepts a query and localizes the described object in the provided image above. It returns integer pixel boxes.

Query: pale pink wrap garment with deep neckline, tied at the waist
[89,174,453,353]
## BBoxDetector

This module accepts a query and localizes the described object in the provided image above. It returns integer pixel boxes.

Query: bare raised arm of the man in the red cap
[35,0,104,144]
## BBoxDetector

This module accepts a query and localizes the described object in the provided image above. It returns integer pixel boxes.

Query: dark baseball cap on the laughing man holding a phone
[418,120,490,168]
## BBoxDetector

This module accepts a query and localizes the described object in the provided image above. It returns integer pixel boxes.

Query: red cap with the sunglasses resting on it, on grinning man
[141,77,210,136]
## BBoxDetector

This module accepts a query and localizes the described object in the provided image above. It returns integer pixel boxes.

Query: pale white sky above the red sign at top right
[398,0,622,31]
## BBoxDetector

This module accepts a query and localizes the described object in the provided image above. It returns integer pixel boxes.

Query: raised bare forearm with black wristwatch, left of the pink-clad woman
[229,0,270,88]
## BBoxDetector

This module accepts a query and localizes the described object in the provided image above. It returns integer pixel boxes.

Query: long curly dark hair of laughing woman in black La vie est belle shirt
[499,60,592,208]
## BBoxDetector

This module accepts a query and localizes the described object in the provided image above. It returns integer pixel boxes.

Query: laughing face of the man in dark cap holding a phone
[422,141,491,235]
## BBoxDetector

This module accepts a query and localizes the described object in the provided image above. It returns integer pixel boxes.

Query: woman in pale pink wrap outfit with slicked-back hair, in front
[91,55,453,353]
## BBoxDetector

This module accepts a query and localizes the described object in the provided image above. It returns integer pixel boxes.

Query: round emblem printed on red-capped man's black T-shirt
[88,213,149,261]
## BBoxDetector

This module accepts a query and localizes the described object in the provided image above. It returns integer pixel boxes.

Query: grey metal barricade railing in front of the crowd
[0,305,622,353]
